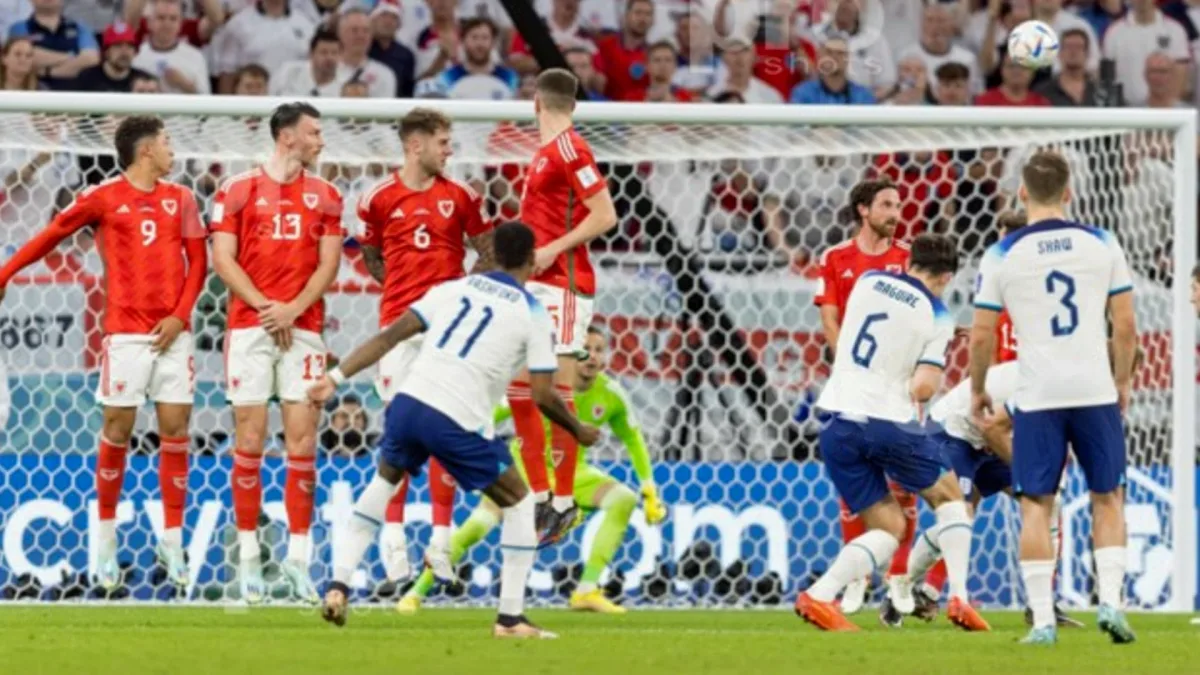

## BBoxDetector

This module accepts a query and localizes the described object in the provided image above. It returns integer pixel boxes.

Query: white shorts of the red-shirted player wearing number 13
[226,325,325,406]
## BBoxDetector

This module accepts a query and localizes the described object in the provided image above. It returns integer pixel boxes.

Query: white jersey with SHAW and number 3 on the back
[974,220,1133,411]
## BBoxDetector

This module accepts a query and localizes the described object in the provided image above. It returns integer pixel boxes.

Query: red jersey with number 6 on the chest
[358,173,488,327]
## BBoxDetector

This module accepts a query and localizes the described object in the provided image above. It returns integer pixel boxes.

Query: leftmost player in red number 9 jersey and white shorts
[0,115,208,591]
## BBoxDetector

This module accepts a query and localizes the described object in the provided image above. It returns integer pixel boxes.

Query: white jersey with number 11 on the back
[397,271,558,438]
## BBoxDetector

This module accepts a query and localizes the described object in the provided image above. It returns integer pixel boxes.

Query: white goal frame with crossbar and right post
[0,91,1198,611]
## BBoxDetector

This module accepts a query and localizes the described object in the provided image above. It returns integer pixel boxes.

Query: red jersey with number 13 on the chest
[212,168,342,333]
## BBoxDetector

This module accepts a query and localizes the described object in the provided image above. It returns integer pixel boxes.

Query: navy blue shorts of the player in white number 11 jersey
[379,394,512,490]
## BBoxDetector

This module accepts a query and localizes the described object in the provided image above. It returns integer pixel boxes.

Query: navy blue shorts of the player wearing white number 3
[1013,404,1126,497]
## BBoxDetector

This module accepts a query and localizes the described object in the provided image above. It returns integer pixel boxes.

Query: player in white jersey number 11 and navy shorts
[310,222,599,638]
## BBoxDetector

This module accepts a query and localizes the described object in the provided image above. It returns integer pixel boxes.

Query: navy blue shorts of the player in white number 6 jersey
[820,416,948,513]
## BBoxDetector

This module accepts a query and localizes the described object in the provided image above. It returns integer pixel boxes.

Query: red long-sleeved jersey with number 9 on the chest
[0,175,208,335]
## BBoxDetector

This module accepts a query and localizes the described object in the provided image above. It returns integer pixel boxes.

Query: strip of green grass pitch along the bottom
[0,605,1200,675]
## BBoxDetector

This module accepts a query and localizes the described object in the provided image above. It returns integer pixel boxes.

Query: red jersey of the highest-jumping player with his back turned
[521,129,608,295]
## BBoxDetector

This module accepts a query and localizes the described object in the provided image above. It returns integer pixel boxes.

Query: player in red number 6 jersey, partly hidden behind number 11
[358,108,492,583]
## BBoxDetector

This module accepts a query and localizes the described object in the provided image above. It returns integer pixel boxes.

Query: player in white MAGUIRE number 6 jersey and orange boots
[796,234,990,631]
